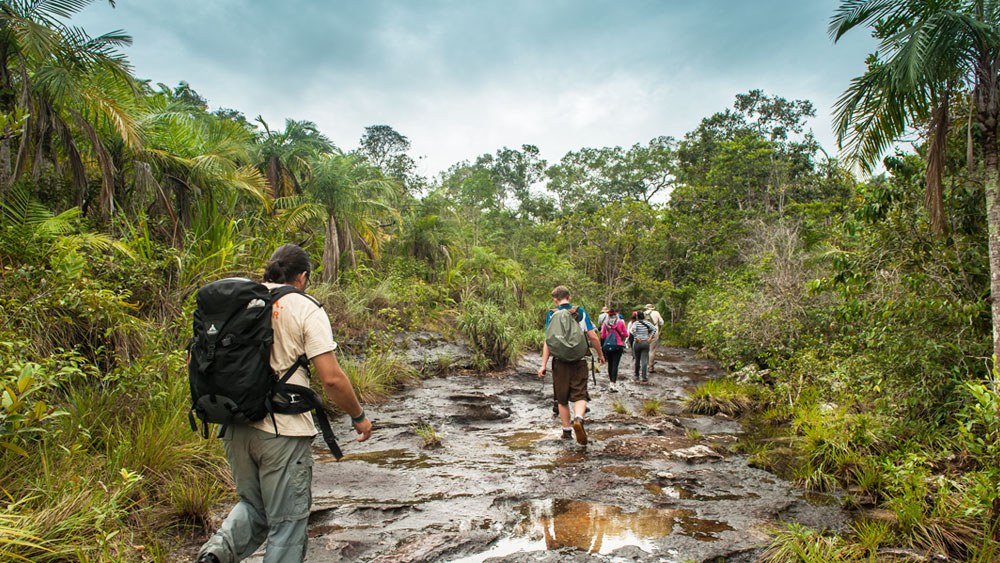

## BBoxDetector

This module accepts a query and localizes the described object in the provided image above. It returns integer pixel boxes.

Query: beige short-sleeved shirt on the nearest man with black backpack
[251,283,337,436]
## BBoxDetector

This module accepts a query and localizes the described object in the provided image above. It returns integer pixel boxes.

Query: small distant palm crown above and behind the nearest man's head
[256,115,334,199]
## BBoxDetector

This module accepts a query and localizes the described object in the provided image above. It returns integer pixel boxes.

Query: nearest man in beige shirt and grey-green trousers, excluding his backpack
[198,244,372,563]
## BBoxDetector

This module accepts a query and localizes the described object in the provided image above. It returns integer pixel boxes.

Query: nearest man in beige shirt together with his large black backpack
[189,244,371,563]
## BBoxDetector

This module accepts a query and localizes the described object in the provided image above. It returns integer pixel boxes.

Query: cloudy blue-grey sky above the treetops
[71,0,874,176]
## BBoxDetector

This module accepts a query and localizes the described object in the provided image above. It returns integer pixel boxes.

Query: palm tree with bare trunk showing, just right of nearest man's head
[279,153,402,282]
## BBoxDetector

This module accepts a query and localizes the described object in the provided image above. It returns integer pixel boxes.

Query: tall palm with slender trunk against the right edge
[830,0,1000,390]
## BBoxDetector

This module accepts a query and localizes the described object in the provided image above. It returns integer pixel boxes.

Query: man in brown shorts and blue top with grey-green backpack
[538,285,605,445]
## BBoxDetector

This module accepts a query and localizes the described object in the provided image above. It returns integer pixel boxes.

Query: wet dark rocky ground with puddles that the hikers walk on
[225,343,844,563]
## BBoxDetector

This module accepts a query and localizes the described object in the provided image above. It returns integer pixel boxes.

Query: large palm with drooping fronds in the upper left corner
[0,0,139,218]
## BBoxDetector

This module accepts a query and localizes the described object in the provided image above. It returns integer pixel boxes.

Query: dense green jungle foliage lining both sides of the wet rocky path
[0,2,1000,561]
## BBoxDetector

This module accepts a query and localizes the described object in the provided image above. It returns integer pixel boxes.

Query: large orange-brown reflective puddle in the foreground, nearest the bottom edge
[452,499,734,563]
